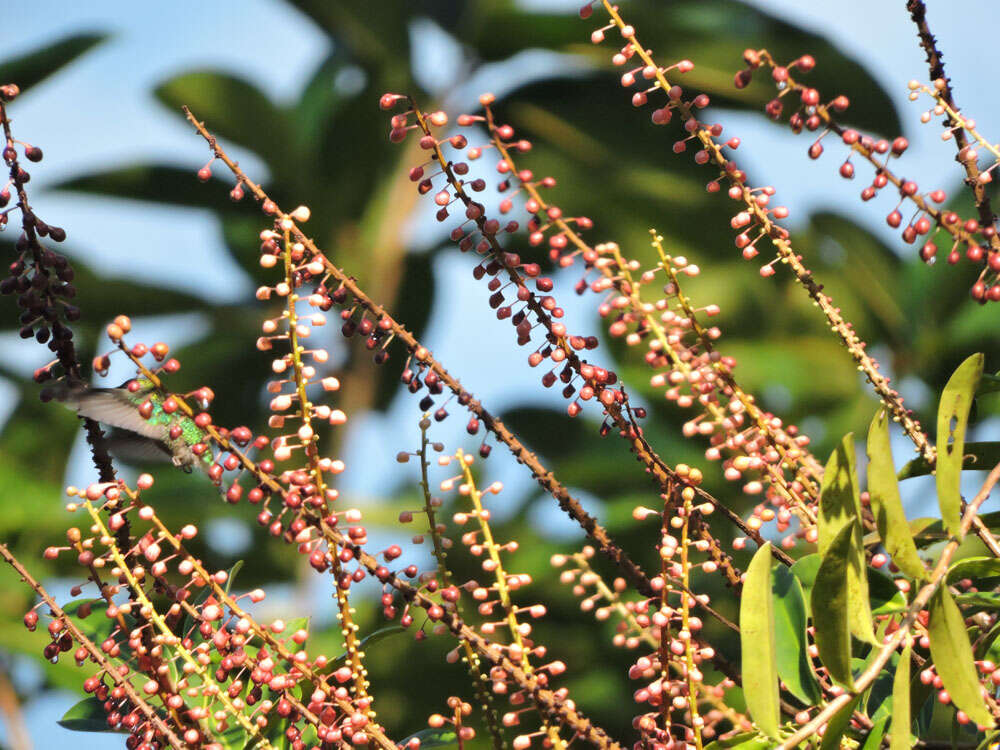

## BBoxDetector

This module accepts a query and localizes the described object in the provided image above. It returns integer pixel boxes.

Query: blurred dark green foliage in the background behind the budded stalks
[0,0,1000,748]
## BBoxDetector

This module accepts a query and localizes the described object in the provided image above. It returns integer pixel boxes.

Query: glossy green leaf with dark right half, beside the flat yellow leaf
[771,565,823,706]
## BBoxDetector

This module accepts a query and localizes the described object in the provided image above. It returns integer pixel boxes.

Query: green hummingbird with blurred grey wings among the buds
[47,376,214,473]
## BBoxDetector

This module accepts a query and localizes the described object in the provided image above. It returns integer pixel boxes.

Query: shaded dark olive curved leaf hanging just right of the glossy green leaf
[816,524,854,690]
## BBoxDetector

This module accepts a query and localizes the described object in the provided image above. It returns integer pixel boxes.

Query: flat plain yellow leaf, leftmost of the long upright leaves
[740,542,781,739]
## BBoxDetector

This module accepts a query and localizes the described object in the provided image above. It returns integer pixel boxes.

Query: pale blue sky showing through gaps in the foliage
[0,0,1000,749]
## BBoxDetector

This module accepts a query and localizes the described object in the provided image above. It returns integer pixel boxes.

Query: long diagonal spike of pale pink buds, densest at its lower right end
[459,88,820,544]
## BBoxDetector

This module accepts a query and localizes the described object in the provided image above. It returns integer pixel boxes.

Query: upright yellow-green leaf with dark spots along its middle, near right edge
[936,354,983,534]
